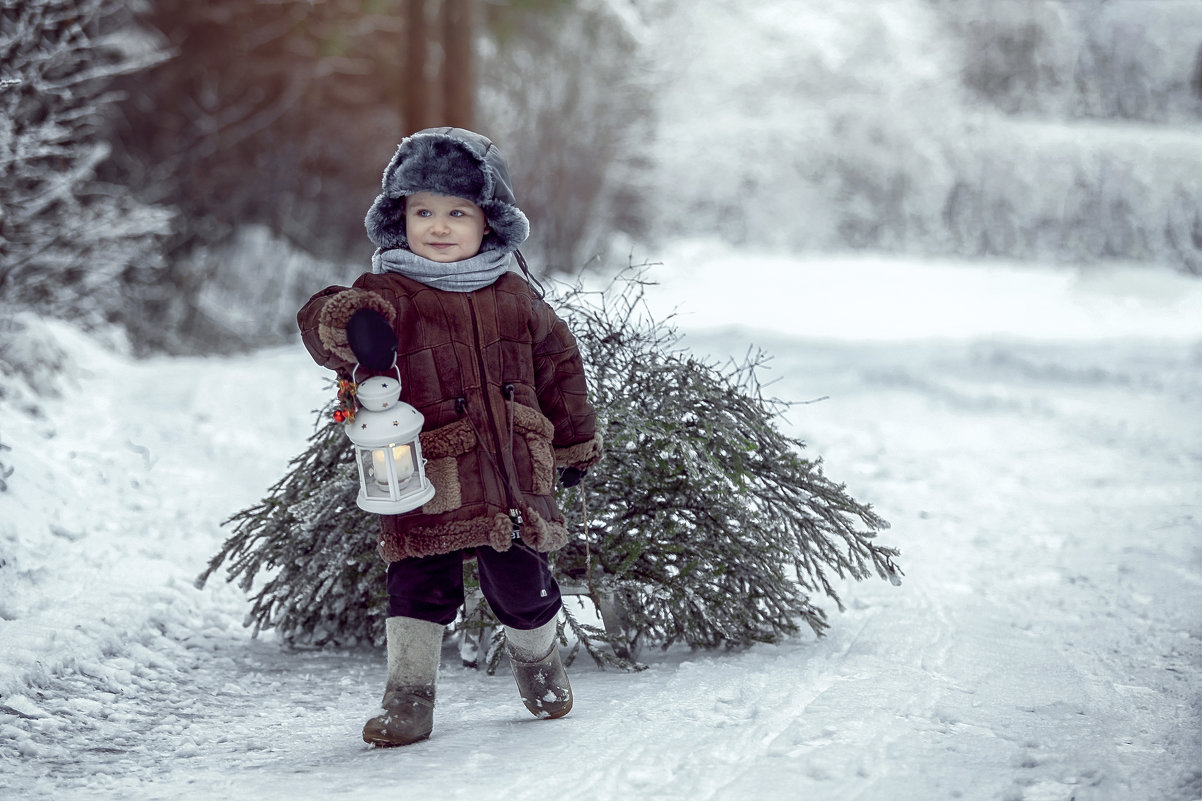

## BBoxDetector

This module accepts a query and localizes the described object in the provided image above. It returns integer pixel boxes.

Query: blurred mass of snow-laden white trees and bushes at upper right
[648,0,1202,274]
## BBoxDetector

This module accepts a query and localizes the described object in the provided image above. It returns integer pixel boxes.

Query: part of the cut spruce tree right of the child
[557,271,900,647]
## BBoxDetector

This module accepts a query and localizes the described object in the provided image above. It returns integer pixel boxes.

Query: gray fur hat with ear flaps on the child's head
[364,127,530,253]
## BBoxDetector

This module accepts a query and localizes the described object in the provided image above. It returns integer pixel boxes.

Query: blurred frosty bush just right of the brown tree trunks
[477,0,659,269]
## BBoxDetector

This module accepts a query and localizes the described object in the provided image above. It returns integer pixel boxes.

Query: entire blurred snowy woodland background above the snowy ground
[0,0,1202,354]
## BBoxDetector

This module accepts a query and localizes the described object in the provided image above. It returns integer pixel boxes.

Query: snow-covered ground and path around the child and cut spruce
[0,243,1202,801]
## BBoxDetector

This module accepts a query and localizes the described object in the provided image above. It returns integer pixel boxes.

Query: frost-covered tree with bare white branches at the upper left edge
[0,0,169,336]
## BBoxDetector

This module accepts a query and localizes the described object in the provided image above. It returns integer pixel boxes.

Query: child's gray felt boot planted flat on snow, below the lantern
[363,617,446,747]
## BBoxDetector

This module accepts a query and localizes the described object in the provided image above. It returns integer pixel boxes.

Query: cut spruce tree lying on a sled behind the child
[198,272,902,666]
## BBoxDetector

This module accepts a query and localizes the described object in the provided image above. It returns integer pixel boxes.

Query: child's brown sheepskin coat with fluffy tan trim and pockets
[297,267,601,562]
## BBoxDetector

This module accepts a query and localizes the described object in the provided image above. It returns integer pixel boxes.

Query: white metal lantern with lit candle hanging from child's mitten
[343,370,434,515]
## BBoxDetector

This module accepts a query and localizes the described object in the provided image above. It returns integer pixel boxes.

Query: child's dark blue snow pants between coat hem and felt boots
[388,541,563,630]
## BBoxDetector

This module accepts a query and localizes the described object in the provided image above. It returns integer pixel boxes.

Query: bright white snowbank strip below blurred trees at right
[636,239,1202,342]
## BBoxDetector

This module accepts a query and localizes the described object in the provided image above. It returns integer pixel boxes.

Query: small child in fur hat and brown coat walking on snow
[297,127,601,746]
